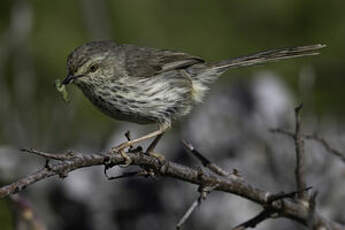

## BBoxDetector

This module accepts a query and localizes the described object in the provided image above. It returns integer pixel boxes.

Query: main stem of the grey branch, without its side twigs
[0,147,344,229]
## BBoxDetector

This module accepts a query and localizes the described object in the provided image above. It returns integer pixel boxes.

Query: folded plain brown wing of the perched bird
[123,45,205,77]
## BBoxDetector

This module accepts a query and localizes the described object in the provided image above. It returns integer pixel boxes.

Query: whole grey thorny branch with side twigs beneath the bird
[0,109,345,230]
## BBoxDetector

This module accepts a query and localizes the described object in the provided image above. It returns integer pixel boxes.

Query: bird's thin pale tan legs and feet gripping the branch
[112,125,170,166]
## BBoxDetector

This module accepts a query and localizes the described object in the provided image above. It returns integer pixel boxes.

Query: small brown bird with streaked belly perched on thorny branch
[62,41,325,164]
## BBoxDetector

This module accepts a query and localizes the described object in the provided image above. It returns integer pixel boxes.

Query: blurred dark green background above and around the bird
[0,0,345,229]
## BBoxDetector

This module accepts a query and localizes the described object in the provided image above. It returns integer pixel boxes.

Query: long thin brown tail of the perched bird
[210,44,326,71]
